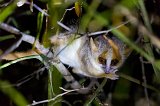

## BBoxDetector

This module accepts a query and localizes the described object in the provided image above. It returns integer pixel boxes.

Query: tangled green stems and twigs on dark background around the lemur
[0,0,160,106]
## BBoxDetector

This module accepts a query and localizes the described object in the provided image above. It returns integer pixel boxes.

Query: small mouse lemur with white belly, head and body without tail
[50,25,125,80]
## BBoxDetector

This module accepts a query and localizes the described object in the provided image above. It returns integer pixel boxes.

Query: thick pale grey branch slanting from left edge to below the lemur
[0,23,88,93]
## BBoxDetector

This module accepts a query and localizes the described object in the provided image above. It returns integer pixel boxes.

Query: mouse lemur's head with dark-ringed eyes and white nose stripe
[90,36,124,79]
